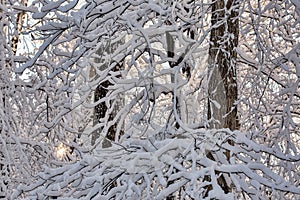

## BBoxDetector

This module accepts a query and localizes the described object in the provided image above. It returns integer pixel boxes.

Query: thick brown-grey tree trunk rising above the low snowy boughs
[208,0,239,130]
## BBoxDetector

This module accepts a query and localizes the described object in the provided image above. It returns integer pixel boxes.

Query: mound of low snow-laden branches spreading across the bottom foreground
[11,129,300,199]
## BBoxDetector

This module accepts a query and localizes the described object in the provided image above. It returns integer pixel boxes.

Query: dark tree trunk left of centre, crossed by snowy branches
[91,41,124,147]
